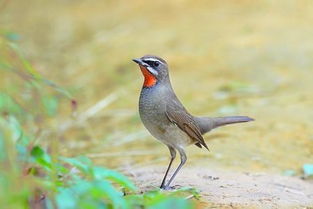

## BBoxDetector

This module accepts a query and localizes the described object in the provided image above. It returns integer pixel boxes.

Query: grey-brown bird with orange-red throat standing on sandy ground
[132,55,254,190]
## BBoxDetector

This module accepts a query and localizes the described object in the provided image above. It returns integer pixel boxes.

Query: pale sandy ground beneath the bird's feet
[127,167,313,208]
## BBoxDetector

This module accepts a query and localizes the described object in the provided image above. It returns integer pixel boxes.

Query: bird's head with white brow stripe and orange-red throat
[133,55,168,87]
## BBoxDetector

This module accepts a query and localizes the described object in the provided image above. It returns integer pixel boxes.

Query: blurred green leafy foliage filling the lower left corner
[0,33,193,209]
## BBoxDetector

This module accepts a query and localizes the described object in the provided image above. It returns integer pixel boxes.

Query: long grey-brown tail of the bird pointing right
[195,116,254,134]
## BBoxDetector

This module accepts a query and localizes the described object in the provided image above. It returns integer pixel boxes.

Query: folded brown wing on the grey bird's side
[165,106,209,150]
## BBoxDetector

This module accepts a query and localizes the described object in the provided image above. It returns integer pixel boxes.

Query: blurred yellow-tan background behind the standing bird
[0,0,313,207]
